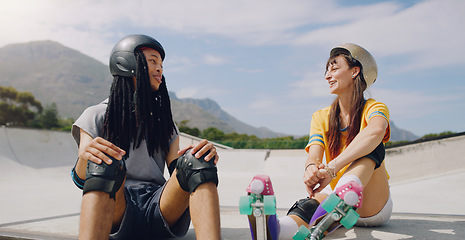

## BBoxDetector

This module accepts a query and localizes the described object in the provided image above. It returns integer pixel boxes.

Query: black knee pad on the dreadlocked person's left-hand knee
[82,157,126,199]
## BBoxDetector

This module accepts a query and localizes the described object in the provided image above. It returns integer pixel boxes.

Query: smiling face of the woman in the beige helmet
[325,56,360,95]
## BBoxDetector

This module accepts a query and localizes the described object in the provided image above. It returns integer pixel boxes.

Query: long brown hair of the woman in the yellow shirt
[326,53,367,159]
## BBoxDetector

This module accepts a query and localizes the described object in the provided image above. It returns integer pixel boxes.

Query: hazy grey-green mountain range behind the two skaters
[0,41,417,141]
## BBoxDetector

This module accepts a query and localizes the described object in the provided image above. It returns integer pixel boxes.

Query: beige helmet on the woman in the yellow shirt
[330,43,378,88]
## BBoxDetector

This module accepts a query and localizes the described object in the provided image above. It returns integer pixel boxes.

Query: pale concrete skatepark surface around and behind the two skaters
[0,127,465,240]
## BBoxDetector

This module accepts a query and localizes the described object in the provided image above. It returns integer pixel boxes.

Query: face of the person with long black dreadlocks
[142,48,163,91]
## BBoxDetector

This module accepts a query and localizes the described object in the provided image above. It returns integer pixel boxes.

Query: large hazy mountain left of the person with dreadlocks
[0,41,111,118]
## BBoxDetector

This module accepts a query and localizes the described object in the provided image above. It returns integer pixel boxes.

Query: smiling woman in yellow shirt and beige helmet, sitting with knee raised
[279,43,392,239]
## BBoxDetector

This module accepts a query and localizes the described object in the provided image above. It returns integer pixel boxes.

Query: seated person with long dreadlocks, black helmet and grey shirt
[72,35,220,239]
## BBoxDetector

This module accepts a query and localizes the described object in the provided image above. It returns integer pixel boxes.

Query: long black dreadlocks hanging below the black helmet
[103,49,176,157]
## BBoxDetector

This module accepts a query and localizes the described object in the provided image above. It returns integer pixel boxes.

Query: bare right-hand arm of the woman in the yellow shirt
[328,116,389,173]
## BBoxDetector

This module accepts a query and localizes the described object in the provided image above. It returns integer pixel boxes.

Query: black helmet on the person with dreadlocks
[110,35,165,77]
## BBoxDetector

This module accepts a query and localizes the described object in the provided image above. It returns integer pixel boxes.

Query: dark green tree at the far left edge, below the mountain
[0,86,42,126]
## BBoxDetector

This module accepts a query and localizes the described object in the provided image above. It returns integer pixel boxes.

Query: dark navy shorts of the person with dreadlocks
[110,180,190,239]
